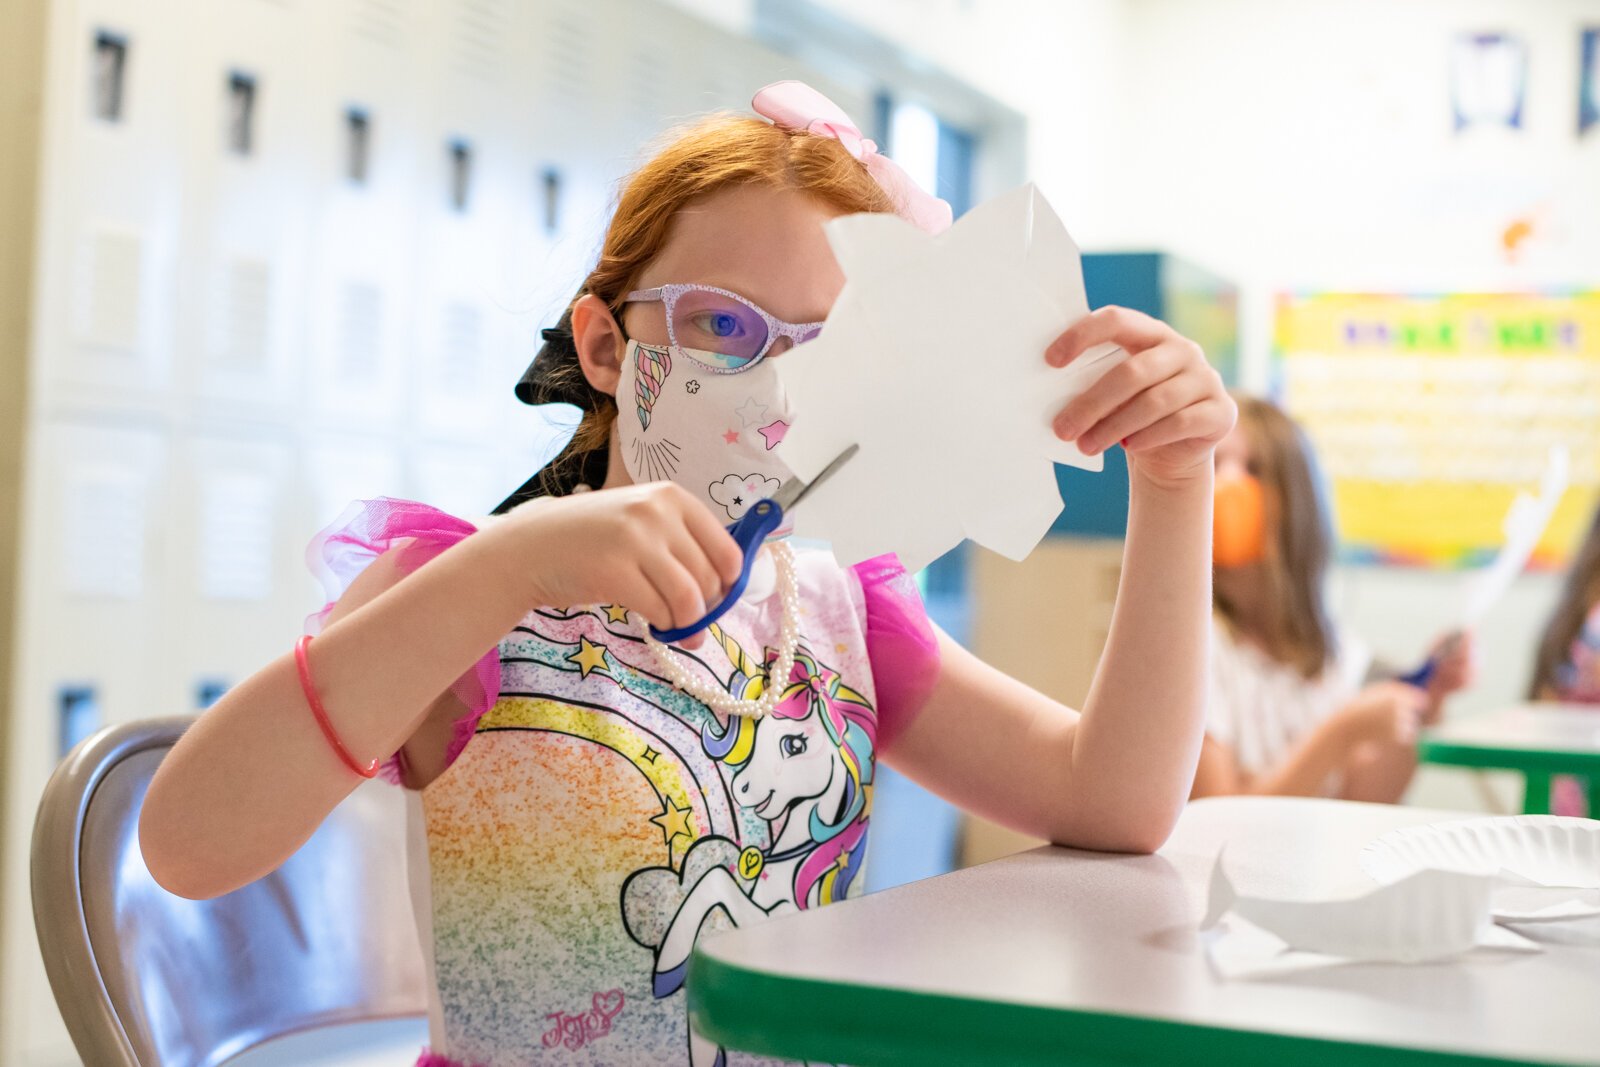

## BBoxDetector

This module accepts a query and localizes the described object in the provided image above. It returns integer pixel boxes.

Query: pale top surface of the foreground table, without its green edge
[701,797,1600,1064]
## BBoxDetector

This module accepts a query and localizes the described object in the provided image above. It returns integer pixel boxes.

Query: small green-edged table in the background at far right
[1418,704,1600,817]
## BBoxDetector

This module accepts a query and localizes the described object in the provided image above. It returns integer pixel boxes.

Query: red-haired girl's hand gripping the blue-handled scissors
[499,482,744,648]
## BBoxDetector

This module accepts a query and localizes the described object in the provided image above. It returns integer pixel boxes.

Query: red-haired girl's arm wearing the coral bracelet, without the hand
[139,521,533,897]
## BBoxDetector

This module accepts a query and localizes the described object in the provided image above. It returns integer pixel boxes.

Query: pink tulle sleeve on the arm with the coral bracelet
[306,496,499,784]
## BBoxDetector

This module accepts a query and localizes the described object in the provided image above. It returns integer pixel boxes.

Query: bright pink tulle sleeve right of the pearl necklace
[851,553,939,752]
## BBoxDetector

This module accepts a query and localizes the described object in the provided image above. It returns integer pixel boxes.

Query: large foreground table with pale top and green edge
[688,797,1600,1067]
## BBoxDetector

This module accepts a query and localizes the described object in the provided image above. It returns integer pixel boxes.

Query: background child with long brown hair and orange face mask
[1194,397,1472,801]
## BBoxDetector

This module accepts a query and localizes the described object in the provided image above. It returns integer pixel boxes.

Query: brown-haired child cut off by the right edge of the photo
[1528,509,1600,816]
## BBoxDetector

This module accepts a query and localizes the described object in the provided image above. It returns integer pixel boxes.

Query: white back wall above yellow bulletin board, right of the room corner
[1113,0,1600,386]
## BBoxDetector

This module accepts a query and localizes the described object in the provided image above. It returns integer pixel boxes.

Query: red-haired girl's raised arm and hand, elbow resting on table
[885,307,1235,851]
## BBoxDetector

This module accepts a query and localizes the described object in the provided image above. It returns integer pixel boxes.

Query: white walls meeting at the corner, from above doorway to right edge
[800,0,1600,415]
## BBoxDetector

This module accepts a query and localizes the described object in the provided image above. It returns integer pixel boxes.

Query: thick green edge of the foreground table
[688,949,1561,1067]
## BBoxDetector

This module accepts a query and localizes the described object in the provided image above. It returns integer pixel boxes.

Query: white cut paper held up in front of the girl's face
[778,186,1126,571]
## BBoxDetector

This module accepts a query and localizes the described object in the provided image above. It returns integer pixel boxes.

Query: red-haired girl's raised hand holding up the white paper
[1045,307,1238,485]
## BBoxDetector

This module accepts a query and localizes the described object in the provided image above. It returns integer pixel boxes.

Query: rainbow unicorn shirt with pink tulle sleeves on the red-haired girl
[314,501,938,1067]
